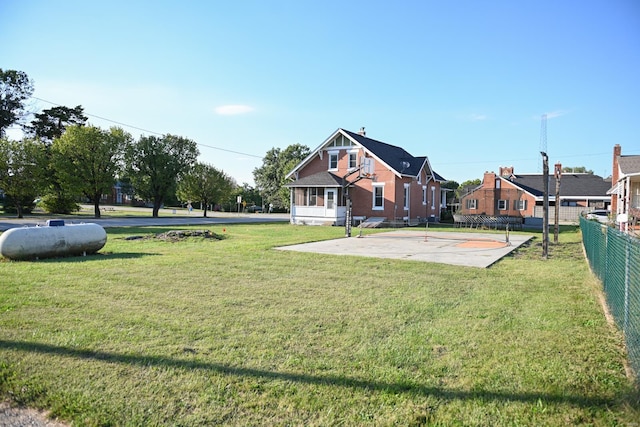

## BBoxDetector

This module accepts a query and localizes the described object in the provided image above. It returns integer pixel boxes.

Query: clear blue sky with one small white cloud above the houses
[0,0,640,184]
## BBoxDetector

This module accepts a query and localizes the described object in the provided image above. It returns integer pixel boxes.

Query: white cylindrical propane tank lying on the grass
[0,221,107,260]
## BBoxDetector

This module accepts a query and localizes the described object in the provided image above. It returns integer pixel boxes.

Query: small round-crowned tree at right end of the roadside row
[177,163,235,218]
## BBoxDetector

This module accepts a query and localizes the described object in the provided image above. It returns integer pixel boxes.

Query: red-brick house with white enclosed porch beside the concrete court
[286,128,446,225]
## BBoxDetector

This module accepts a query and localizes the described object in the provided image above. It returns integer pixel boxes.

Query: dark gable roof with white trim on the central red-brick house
[286,128,445,181]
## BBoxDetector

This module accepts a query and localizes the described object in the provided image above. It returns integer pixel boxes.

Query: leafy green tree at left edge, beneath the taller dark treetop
[0,138,45,218]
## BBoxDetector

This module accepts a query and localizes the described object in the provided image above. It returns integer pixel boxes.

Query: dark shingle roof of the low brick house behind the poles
[510,173,611,197]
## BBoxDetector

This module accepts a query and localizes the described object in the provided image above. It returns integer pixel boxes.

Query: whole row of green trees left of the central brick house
[0,69,309,217]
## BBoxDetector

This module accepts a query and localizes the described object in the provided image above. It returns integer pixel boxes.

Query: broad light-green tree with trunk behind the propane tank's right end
[52,125,133,218]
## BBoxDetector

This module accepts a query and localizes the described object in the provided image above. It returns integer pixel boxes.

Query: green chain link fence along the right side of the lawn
[580,217,640,382]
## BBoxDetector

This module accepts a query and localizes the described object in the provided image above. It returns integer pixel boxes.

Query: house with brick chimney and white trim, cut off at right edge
[607,144,640,231]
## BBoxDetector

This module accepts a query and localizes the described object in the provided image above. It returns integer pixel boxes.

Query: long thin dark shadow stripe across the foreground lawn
[0,340,615,408]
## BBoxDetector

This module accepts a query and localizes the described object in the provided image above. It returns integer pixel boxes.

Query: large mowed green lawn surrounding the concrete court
[0,224,640,426]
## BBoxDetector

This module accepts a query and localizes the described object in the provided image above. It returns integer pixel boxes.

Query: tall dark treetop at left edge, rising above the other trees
[0,68,33,138]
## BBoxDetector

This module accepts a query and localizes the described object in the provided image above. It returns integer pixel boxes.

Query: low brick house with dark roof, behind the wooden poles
[458,165,611,220]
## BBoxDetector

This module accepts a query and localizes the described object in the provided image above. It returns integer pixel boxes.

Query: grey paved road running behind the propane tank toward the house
[0,206,289,231]
